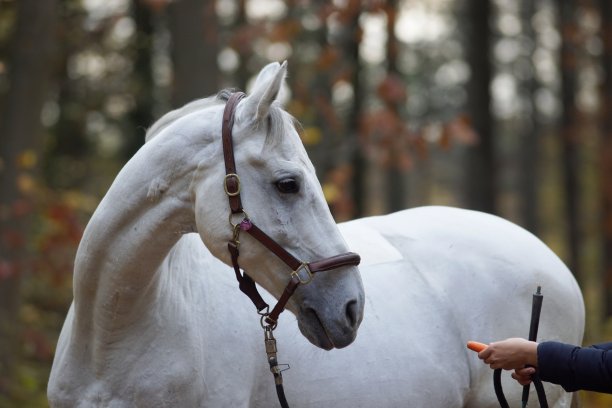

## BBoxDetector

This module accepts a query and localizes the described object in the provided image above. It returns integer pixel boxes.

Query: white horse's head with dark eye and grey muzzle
[188,63,364,349]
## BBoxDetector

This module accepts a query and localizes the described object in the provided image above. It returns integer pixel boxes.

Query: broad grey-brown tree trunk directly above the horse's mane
[168,0,219,107]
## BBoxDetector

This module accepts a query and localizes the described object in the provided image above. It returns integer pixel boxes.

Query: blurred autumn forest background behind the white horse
[0,0,612,407]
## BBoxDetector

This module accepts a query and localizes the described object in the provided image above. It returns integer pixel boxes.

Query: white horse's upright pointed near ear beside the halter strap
[240,61,287,122]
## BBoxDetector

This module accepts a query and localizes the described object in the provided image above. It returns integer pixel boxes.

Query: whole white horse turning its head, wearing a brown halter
[49,64,584,408]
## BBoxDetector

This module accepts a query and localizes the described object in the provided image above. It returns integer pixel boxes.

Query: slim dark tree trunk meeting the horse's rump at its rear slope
[558,0,580,277]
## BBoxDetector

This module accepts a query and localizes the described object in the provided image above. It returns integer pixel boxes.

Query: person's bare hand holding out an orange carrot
[478,338,538,370]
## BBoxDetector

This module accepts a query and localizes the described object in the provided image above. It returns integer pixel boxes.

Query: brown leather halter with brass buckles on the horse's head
[221,92,361,326]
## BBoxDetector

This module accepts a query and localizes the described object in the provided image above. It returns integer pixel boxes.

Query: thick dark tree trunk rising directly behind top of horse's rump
[464,0,497,213]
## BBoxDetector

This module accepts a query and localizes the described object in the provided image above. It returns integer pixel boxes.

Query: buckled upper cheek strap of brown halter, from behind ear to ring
[221,92,245,214]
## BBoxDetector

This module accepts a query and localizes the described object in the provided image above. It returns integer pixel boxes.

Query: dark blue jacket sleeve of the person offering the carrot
[538,341,612,394]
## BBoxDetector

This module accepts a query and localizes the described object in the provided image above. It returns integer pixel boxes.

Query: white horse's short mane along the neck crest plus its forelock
[145,88,301,152]
